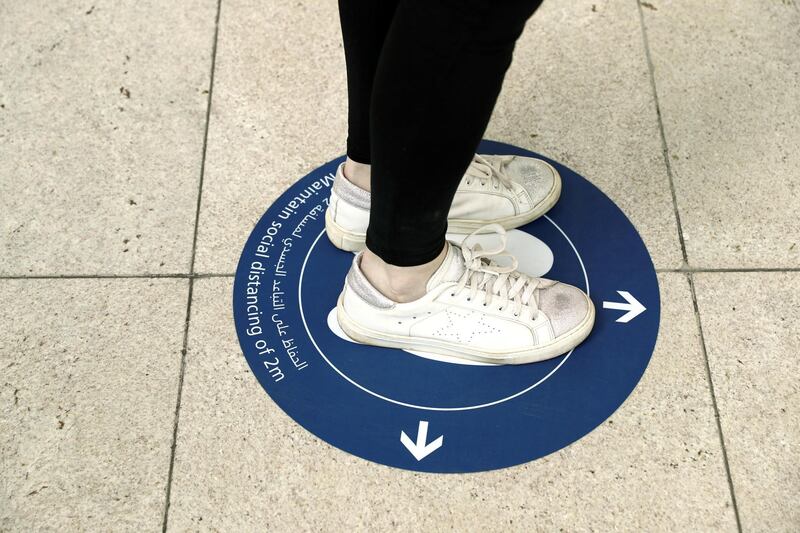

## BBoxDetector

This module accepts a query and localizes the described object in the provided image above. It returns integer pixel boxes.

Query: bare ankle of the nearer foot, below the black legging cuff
[361,246,447,303]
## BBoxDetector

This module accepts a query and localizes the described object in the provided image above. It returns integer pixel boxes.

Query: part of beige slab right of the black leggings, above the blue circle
[487,0,683,269]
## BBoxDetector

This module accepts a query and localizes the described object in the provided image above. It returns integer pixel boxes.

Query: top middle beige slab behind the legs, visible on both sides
[197,0,682,272]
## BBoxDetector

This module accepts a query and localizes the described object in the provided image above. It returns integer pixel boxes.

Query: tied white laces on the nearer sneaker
[453,224,555,320]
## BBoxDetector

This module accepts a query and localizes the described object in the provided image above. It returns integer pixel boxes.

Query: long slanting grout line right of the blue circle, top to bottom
[636,0,742,533]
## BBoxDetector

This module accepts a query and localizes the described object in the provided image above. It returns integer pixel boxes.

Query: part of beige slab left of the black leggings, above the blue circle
[196,0,347,272]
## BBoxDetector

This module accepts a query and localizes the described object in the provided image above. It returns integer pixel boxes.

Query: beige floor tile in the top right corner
[643,0,800,268]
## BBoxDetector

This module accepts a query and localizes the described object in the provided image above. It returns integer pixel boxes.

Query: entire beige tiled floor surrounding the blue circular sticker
[0,0,800,531]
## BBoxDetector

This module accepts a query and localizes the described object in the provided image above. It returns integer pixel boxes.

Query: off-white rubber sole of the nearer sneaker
[336,295,595,365]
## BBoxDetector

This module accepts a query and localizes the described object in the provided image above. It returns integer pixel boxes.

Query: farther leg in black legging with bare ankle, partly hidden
[339,0,399,190]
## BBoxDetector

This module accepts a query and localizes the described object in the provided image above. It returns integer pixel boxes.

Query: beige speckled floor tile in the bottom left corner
[0,279,187,531]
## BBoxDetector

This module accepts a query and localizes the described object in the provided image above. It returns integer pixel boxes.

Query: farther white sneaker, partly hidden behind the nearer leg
[325,154,561,252]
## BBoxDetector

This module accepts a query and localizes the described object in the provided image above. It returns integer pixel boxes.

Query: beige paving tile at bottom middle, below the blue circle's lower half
[169,274,736,531]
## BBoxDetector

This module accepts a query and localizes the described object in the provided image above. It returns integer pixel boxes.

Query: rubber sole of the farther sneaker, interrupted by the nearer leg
[325,161,561,252]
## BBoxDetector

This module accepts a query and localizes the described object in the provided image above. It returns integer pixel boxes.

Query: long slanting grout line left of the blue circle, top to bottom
[161,0,222,532]
